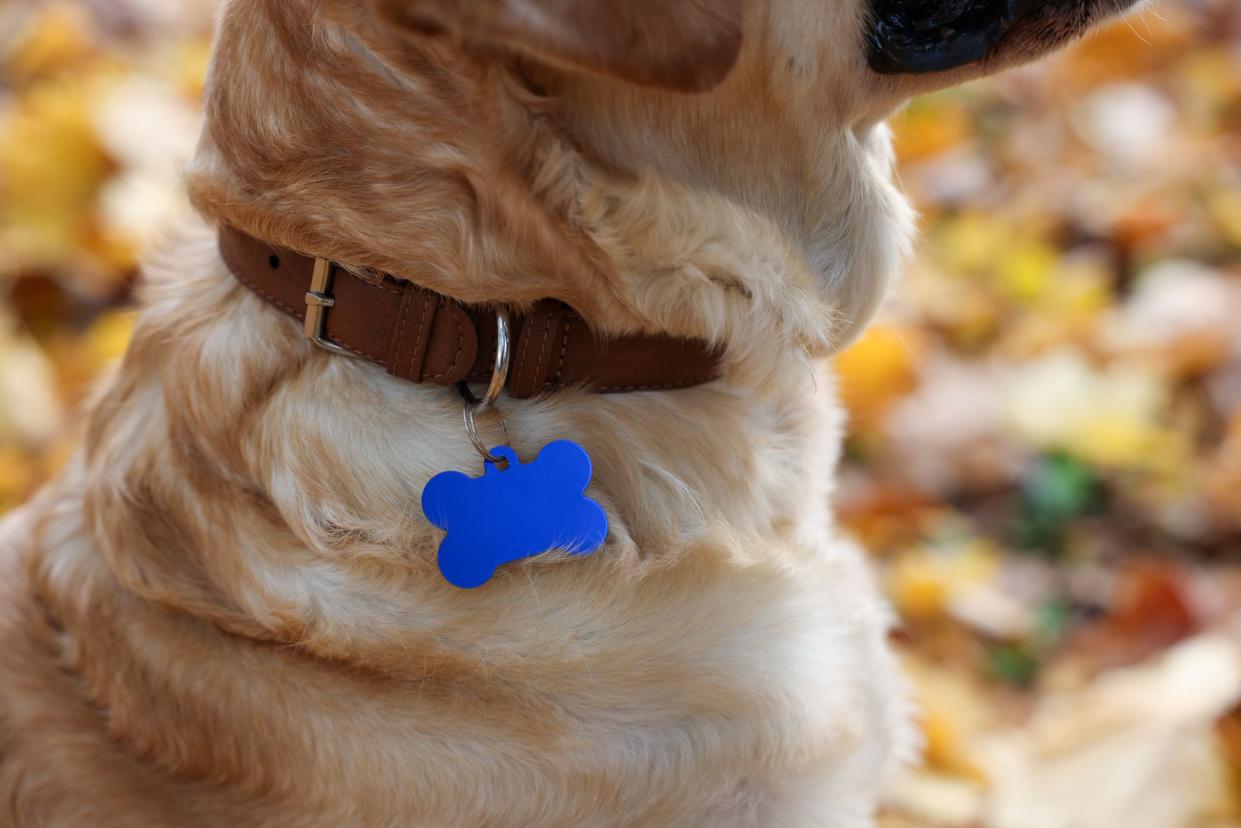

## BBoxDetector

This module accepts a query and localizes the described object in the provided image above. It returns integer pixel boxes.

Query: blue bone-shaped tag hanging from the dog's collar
[422,439,608,590]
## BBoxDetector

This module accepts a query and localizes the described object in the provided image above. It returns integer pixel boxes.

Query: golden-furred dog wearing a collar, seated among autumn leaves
[0,0,1128,828]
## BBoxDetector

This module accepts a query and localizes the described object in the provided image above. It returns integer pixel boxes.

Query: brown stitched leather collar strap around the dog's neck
[220,226,722,398]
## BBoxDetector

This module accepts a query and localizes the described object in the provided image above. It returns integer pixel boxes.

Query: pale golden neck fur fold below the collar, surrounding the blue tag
[55,213,839,667]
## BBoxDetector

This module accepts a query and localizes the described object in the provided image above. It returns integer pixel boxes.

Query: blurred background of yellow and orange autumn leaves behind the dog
[0,0,1241,828]
